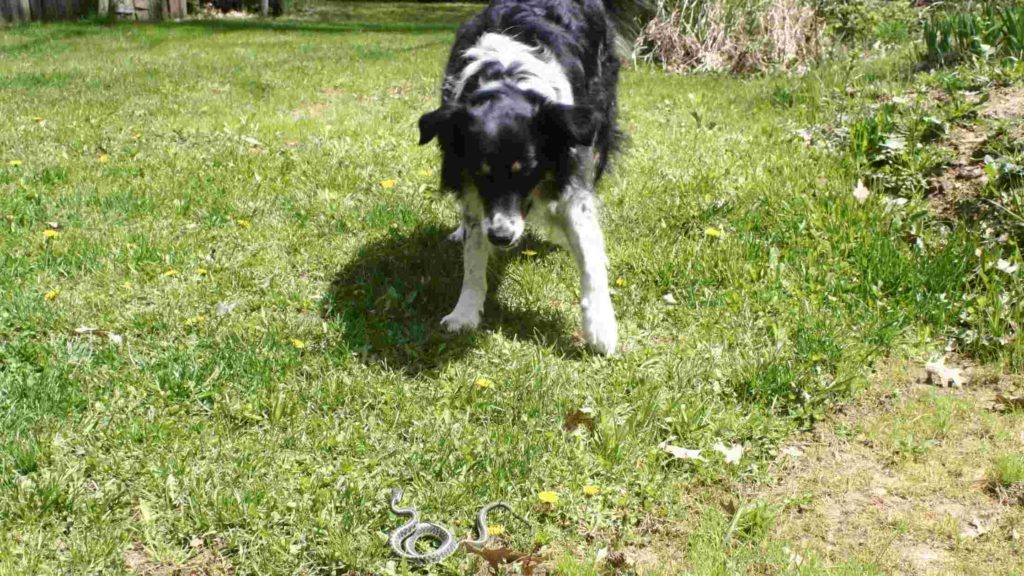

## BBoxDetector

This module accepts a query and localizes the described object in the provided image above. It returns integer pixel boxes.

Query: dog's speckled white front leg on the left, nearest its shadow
[441,218,490,332]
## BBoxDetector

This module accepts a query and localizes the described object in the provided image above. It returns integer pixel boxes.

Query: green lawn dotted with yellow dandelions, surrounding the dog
[0,3,1019,574]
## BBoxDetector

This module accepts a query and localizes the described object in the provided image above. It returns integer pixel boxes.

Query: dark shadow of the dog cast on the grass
[323,227,579,373]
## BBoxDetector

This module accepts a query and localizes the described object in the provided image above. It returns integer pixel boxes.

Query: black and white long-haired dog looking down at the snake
[420,0,618,355]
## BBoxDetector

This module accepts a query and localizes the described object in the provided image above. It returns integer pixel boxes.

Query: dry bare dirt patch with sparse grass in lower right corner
[767,358,1024,575]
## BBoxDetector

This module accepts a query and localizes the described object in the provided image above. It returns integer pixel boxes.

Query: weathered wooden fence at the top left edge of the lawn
[0,0,187,23]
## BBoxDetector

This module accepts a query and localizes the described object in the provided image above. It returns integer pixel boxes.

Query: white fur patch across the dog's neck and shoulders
[450,32,572,105]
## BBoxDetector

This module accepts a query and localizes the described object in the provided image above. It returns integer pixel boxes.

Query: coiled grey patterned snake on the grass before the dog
[388,488,529,566]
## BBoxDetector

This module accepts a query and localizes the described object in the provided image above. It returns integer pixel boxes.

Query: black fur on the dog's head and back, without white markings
[420,0,620,223]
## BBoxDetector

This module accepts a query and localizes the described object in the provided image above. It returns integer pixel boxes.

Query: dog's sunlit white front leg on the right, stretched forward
[559,188,618,356]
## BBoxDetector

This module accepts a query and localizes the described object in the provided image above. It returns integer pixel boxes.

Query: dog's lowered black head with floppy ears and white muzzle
[420,84,597,248]
